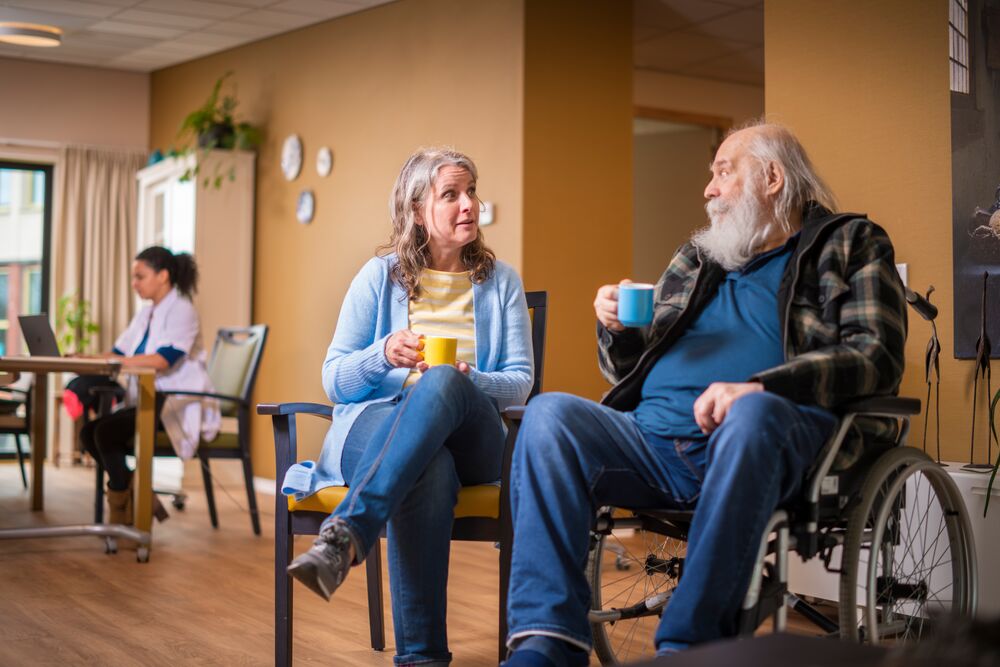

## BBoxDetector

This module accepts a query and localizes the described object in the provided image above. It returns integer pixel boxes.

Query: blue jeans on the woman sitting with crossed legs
[331,366,504,665]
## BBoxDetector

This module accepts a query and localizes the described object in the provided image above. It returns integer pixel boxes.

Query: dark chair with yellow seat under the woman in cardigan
[257,292,546,667]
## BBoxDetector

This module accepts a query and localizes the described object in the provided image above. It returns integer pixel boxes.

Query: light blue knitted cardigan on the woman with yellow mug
[281,255,534,500]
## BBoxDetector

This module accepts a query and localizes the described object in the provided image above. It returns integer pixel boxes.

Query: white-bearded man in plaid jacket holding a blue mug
[505,123,906,667]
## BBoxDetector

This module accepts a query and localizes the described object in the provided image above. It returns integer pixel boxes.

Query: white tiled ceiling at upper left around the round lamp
[0,0,392,72]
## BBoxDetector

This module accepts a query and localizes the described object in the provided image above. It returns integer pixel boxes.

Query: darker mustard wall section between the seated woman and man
[523,0,632,398]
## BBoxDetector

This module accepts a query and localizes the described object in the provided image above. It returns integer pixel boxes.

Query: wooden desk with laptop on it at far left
[0,357,156,562]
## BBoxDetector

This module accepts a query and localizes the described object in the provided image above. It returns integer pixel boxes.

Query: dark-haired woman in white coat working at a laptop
[80,246,219,525]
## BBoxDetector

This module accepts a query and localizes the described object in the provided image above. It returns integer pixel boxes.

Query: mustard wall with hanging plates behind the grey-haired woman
[150,0,524,476]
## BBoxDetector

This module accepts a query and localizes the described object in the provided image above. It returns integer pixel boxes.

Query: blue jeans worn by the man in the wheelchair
[507,392,836,651]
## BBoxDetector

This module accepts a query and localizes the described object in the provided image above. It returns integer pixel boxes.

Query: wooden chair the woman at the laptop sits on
[96,324,267,535]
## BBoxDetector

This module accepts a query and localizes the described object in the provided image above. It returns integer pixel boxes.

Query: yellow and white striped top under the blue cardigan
[403,269,476,387]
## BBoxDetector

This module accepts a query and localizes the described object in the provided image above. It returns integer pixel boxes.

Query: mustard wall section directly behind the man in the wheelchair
[764,0,986,461]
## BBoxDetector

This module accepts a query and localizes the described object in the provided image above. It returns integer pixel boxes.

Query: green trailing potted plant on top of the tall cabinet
[177,71,261,188]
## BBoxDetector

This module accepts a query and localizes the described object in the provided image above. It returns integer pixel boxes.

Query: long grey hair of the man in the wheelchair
[727,120,837,231]
